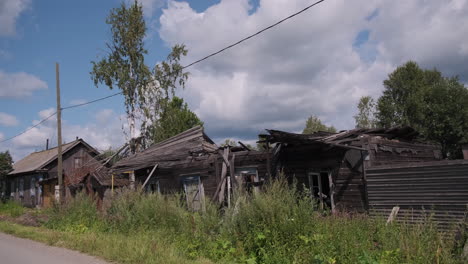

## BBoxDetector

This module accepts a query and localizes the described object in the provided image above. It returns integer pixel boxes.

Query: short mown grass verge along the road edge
[0,221,211,264]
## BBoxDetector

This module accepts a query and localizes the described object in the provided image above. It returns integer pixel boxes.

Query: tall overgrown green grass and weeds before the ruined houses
[46,179,462,263]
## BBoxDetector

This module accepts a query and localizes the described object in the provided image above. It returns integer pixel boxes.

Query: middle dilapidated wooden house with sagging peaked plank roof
[111,126,268,210]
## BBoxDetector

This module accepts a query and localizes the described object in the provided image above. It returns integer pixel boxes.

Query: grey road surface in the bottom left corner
[0,233,109,264]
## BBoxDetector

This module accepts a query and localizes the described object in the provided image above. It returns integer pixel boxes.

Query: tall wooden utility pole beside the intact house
[55,63,65,202]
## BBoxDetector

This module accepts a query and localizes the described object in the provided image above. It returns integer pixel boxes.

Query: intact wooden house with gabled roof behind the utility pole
[6,139,99,207]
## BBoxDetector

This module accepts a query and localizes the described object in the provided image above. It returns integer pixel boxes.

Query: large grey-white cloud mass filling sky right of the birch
[159,0,468,138]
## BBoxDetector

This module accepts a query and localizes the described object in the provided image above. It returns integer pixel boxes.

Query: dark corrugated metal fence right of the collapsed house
[366,160,468,227]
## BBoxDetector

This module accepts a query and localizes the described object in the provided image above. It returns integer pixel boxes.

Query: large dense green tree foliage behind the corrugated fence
[377,61,468,158]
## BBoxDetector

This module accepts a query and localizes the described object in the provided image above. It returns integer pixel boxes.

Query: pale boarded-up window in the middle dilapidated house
[182,175,205,211]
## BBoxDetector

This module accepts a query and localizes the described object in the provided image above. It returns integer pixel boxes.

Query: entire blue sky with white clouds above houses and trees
[0,0,468,161]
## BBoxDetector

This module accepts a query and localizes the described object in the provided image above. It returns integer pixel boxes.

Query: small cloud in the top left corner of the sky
[0,0,31,36]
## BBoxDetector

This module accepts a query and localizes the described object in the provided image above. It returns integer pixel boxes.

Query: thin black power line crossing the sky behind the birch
[0,0,325,143]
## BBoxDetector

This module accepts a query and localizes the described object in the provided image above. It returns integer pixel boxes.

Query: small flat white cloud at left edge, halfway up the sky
[0,70,47,98]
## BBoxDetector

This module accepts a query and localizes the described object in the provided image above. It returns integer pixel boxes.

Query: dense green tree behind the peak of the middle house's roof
[148,96,203,143]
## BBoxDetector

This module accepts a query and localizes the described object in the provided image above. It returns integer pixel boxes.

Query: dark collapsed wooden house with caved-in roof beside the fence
[262,127,441,212]
